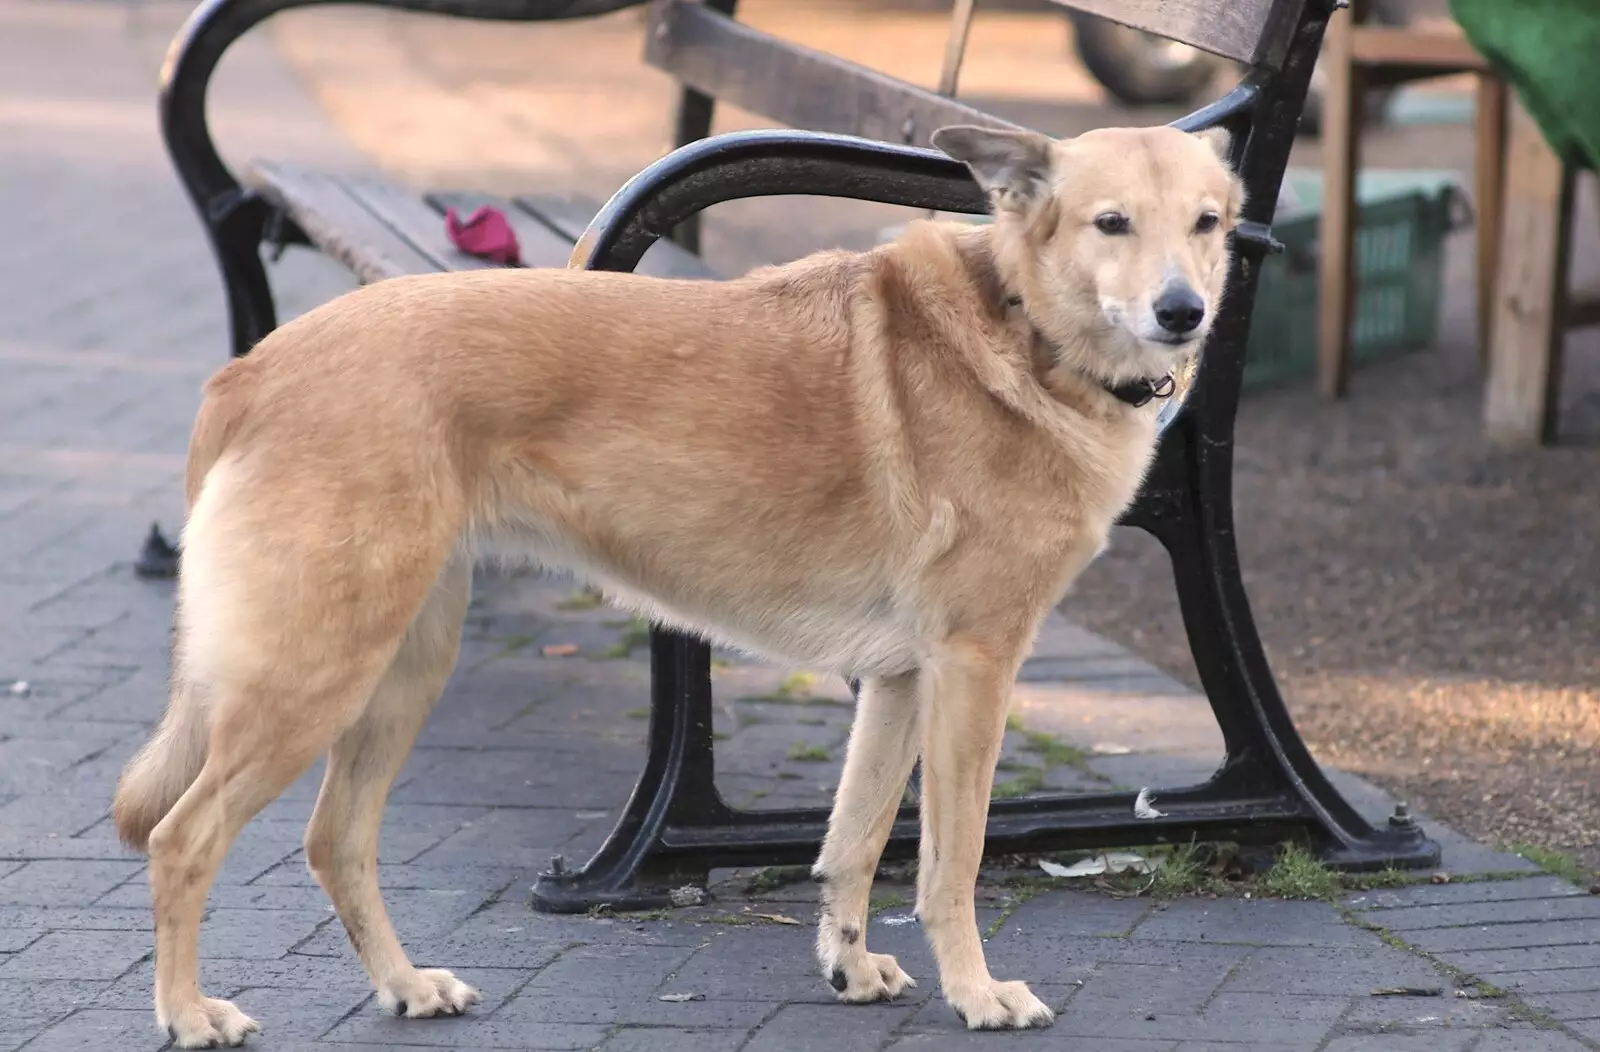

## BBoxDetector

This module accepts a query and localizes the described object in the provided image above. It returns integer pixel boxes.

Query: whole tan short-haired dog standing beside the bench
[115,128,1240,1047]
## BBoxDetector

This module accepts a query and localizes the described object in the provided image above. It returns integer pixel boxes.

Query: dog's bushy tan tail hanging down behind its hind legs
[112,363,248,852]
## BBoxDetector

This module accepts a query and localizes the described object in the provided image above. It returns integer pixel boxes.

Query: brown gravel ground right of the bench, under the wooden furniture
[1067,201,1600,870]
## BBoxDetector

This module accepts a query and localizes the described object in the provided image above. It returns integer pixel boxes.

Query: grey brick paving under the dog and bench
[0,0,1600,1052]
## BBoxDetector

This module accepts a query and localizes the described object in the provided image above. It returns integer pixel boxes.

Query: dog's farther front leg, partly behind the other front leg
[811,673,918,1002]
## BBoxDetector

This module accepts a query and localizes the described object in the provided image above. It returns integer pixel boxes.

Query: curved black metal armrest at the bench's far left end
[160,0,645,214]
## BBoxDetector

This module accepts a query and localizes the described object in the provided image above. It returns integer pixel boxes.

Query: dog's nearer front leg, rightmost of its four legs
[917,640,1054,1030]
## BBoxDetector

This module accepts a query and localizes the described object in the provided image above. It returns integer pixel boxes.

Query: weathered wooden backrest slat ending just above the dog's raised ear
[645,0,1017,145]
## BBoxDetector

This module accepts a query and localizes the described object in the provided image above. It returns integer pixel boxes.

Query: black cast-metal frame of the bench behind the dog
[162,0,1440,911]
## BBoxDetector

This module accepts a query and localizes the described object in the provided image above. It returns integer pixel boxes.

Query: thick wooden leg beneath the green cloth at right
[1483,93,1574,446]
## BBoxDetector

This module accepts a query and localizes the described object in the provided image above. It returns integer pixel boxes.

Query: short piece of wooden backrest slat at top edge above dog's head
[1051,0,1304,69]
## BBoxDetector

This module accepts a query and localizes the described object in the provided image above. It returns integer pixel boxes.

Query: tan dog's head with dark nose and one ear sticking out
[933,126,1243,381]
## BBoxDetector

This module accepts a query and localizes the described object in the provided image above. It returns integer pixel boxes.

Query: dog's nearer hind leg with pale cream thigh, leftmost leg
[140,456,459,1049]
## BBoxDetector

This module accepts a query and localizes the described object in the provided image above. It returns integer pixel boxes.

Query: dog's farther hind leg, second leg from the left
[306,556,478,1017]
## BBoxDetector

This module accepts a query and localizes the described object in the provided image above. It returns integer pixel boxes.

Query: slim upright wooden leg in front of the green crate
[1317,0,1366,398]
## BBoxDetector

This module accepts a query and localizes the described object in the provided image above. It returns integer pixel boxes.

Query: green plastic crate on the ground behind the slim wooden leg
[1245,169,1472,390]
